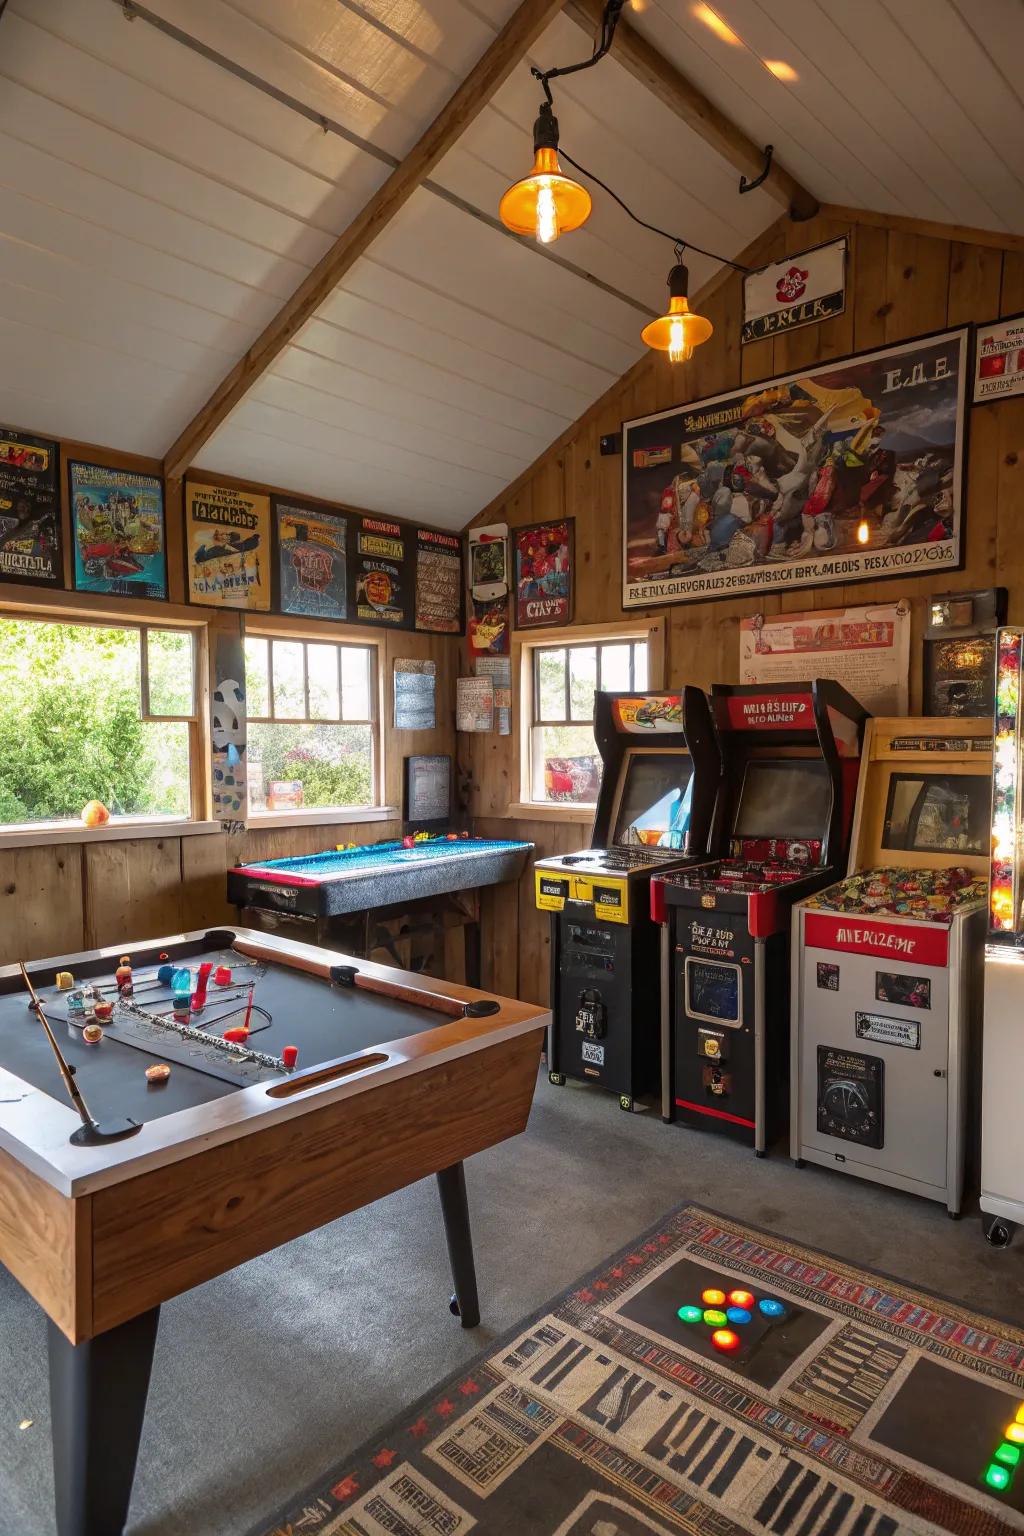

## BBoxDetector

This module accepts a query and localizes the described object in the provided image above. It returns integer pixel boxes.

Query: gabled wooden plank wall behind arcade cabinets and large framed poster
[461,217,1024,1001]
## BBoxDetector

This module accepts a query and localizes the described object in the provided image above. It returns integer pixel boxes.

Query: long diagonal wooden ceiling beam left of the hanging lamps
[164,0,574,479]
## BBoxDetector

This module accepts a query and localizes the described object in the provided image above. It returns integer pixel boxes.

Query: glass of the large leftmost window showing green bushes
[0,614,198,826]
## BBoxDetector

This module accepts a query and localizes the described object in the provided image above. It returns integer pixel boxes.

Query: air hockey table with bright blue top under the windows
[227,834,534,986]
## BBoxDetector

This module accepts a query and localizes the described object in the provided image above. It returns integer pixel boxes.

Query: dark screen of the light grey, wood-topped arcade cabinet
[881,773,990,854]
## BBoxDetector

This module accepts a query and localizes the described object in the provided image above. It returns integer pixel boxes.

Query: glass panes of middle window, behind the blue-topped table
[246,634,376,814]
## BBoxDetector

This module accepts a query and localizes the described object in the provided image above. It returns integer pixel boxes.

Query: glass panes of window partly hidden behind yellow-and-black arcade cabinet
[530,639,648,805]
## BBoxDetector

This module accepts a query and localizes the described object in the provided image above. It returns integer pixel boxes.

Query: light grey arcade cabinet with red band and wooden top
[791,717,992,1217]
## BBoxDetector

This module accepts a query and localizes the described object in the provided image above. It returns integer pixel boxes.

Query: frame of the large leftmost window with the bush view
[0,608,208,848]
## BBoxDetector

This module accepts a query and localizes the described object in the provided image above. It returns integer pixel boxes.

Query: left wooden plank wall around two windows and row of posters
[0,448,464,965]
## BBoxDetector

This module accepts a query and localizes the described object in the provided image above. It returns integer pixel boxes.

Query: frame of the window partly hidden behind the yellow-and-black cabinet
[507,614,666,823]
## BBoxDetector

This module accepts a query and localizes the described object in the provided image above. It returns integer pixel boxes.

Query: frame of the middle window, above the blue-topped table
[243,619,383,829]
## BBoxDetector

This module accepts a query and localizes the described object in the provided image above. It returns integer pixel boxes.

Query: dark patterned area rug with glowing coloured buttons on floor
[253,1206,1024,1536]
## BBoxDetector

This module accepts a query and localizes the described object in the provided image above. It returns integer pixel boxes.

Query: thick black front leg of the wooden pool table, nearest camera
[48,1307,160,1536]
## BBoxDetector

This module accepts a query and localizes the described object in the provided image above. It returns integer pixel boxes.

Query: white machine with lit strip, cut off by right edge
[981,628,1024,1247]
